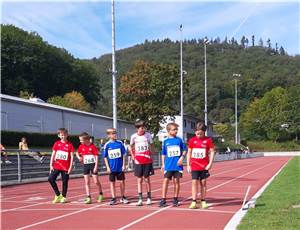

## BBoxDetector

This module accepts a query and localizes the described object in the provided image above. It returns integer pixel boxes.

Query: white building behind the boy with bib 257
[158,115,213,141]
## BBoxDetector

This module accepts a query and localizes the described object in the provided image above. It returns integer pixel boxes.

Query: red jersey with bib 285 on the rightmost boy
[189,136,214,171]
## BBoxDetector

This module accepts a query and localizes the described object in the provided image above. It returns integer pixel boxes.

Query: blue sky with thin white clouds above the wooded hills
[1,0,300,59]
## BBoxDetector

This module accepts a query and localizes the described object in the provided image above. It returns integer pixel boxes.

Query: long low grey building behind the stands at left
[0,94,135,139]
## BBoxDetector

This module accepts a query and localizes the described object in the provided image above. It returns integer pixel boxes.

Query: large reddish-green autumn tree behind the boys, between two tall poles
[118,61,180,134]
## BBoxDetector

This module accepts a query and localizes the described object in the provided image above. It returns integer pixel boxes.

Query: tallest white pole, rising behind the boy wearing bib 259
[111,0,117,129]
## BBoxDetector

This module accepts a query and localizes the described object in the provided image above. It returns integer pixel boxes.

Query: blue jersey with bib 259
[103,140,126,172]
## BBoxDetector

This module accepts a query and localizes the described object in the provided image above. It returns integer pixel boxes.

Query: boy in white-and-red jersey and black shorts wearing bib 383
[129,119,154,206]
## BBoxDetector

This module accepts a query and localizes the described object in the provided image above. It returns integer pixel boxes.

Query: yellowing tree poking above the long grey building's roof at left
[47,91,91,112]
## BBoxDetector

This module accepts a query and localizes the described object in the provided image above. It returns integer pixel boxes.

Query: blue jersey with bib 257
[161,137,186,171]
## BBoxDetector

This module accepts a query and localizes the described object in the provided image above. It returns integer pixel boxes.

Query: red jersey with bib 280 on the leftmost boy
[52,141,74,171]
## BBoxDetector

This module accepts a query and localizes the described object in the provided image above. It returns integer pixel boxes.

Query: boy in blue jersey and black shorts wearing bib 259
[103,128,129,205]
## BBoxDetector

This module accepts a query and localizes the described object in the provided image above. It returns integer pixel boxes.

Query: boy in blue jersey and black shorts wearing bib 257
[159,123,186,207]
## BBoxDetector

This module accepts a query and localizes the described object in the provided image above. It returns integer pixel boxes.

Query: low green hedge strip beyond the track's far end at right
[247,141,300,152]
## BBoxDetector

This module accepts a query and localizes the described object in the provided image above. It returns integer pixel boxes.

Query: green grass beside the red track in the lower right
[238,157,300,230]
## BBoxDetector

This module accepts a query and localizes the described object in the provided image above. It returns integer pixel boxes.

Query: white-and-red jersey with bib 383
[130,132,153,164]
